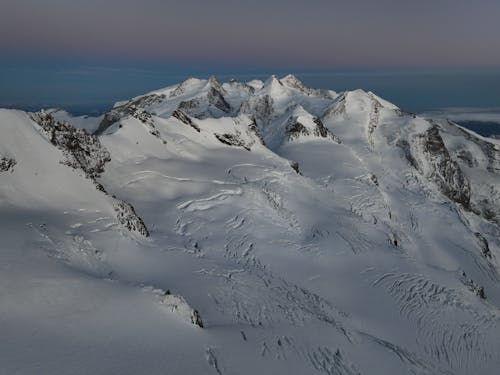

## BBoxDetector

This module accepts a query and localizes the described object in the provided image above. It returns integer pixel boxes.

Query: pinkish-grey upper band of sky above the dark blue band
[0,0,500,68]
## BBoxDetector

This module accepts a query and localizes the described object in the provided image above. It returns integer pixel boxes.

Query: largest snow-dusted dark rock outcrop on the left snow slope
[32,111,111,181]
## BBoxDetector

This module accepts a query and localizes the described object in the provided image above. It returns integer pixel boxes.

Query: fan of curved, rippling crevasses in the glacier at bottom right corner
[373,274,500,369]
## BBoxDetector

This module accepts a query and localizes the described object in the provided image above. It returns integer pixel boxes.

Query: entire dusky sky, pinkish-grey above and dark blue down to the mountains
[0,0,500,118]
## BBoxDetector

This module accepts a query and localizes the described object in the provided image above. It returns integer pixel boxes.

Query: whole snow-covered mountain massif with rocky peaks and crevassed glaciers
[0,76,500,375]
